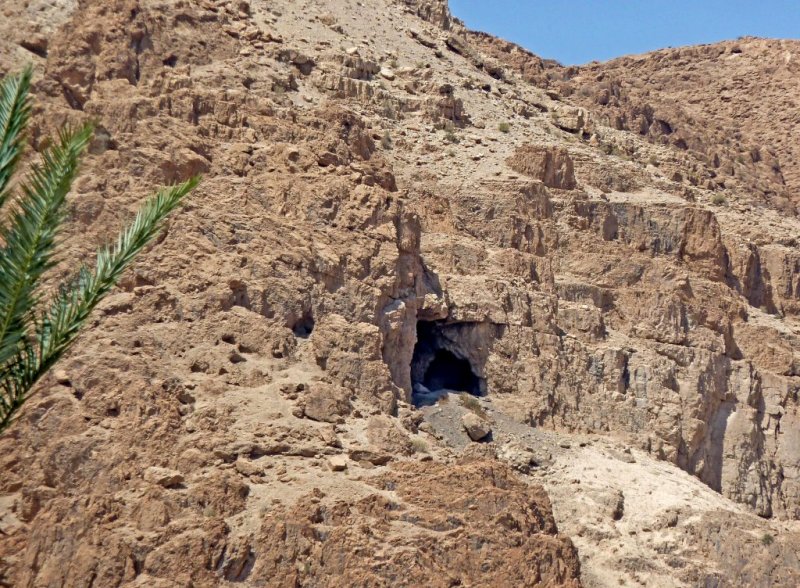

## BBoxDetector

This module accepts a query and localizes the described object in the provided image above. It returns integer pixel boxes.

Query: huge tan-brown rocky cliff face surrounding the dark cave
[0,0,800,586]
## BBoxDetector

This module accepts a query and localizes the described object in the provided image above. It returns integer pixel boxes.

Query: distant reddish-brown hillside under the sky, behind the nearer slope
[562,38,800,215]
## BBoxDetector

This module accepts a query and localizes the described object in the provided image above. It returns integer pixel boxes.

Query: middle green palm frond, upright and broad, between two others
[0,126,92,365]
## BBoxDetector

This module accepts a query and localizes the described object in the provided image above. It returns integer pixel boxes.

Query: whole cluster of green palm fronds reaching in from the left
[0,68,199,433]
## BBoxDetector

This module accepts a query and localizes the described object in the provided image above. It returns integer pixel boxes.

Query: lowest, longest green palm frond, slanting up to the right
[0,178,199,433]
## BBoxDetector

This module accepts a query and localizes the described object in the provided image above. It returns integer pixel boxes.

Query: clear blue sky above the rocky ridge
[450,0,800,65]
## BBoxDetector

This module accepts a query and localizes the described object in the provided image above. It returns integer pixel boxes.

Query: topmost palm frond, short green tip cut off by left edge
[0,67,33,208]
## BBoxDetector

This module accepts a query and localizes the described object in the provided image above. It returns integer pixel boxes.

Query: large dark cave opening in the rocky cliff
[411,321,486,406]
